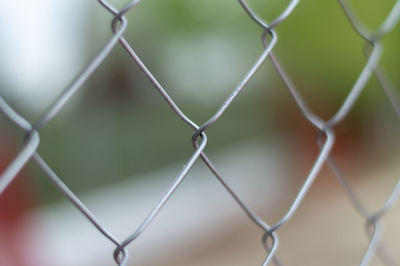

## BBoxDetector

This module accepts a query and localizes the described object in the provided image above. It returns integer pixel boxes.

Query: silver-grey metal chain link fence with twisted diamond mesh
[0,0,400,265]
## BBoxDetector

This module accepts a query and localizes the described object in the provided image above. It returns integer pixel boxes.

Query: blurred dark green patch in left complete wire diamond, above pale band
[35,47,192,194]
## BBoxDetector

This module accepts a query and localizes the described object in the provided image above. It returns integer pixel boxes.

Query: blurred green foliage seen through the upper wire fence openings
[32,0,400,201]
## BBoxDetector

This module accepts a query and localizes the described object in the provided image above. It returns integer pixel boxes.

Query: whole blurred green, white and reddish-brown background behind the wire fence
[0,0,400,266]
